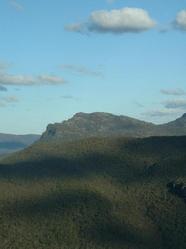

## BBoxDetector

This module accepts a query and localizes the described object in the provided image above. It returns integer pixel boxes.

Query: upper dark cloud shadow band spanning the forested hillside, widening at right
[0,137,186,182]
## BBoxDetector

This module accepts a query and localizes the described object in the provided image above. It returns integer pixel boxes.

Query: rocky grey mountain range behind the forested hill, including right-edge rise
[41,112,186,141]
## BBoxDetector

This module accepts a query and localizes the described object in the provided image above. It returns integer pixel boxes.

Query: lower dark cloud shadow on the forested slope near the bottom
[1,189,157,249]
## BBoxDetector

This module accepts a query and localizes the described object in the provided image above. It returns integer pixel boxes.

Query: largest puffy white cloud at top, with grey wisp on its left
[65,8,156,34]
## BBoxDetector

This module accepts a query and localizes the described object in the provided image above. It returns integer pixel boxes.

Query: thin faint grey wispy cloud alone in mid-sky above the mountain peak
[60,64,103,77]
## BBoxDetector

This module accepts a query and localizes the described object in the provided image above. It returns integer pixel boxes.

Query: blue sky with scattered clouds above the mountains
[0,0,186,134]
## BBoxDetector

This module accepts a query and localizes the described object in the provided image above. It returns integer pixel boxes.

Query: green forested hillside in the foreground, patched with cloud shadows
[0,137,186,249]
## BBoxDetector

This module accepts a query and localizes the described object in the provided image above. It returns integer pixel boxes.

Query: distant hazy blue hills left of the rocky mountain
[0,133,40,156]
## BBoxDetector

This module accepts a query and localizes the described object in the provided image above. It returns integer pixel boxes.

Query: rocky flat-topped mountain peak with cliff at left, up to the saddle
[42,112,154,141]
